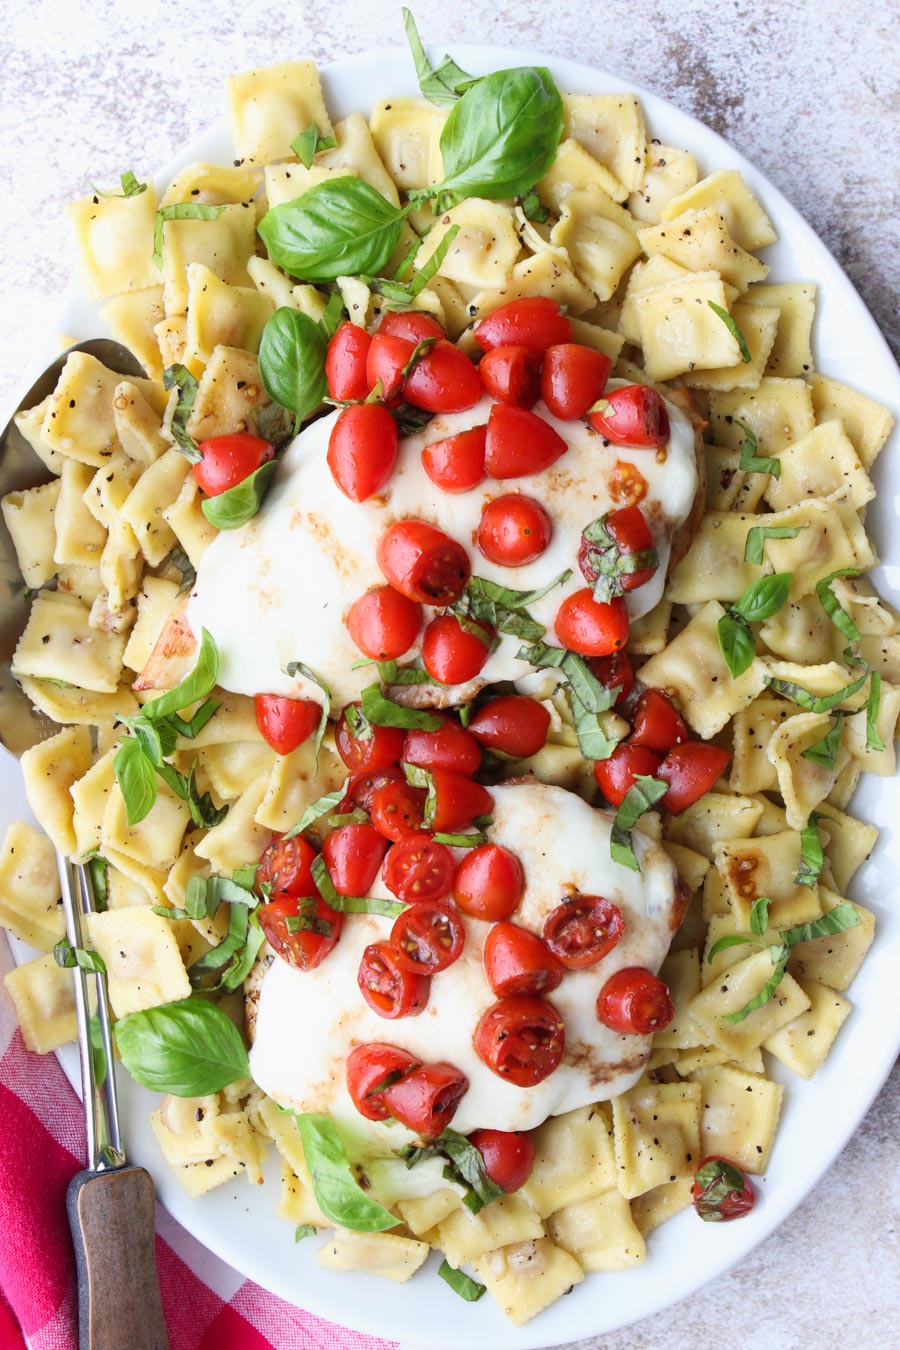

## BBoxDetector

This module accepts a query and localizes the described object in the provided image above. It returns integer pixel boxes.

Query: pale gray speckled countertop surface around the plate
[0,0,900,1350]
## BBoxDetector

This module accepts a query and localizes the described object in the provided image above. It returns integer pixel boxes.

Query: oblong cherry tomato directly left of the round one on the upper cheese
[375,520,471,605]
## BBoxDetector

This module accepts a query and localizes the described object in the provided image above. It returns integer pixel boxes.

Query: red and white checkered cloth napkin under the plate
[0,937,394,1350]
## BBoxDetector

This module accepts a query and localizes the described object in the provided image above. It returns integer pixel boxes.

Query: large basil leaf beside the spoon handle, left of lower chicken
[113,998,250,1096]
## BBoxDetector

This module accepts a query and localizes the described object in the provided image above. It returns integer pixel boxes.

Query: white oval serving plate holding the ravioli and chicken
[0,46,900,1350]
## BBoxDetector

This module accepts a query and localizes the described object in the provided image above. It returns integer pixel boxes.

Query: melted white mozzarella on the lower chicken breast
[250,783,675,1146]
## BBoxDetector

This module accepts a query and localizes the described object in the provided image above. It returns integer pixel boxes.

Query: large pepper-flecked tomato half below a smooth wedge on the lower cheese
[472,996,565,1088]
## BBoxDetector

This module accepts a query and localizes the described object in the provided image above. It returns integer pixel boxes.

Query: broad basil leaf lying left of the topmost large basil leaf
[259,176,406,281]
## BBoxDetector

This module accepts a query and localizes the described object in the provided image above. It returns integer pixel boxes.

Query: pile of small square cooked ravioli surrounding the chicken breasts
[0,44,900,1323]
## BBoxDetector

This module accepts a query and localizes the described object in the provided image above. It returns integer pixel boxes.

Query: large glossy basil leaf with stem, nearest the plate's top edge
[420,66,563,212]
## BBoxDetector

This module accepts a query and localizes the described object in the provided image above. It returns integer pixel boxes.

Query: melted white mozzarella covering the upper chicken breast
[188,398,698,705]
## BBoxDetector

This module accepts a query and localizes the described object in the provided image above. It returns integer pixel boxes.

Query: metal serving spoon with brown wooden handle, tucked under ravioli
[0,338,169,1350]
